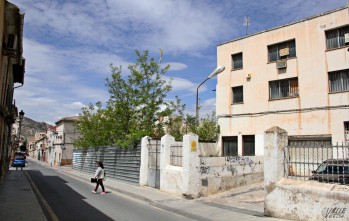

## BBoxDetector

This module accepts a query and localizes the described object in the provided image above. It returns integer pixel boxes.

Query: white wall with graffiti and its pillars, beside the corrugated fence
[139,134,264,198]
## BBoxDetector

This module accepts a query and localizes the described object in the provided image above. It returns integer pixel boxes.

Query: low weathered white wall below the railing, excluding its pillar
[265,179,349,221]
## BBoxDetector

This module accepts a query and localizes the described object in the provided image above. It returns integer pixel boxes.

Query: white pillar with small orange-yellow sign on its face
[182,133,200,198]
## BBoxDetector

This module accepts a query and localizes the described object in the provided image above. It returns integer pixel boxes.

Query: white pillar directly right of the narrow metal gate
[160,134,175,191]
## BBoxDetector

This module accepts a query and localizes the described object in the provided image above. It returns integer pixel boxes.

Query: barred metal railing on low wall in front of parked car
[284,144,349,185]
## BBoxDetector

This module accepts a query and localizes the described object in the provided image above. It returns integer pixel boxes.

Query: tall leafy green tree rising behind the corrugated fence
[76,50,175,147]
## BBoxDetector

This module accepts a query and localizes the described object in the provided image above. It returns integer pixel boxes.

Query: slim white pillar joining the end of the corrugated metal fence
[139,136,151,186]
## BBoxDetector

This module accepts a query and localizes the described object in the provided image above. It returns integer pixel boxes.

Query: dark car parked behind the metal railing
[309,159,349,184]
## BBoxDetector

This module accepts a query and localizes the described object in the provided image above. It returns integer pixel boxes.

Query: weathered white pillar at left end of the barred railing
[264,127,288,189]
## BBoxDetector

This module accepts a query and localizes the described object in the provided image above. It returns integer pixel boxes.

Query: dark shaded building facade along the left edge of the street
[0,0,24,179]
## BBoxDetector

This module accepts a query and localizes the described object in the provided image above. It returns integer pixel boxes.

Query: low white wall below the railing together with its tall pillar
[264,127,349,221]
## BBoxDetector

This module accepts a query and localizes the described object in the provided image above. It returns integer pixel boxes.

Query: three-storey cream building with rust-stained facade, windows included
[216,7,349,156]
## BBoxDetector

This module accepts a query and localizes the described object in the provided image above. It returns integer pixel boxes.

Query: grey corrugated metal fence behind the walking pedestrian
[73,146,141,183]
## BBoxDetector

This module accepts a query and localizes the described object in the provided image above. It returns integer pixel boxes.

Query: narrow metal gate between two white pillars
[148,140,161,189]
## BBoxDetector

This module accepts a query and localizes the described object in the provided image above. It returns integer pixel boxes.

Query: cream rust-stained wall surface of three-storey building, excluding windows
[216,8,349,155]
